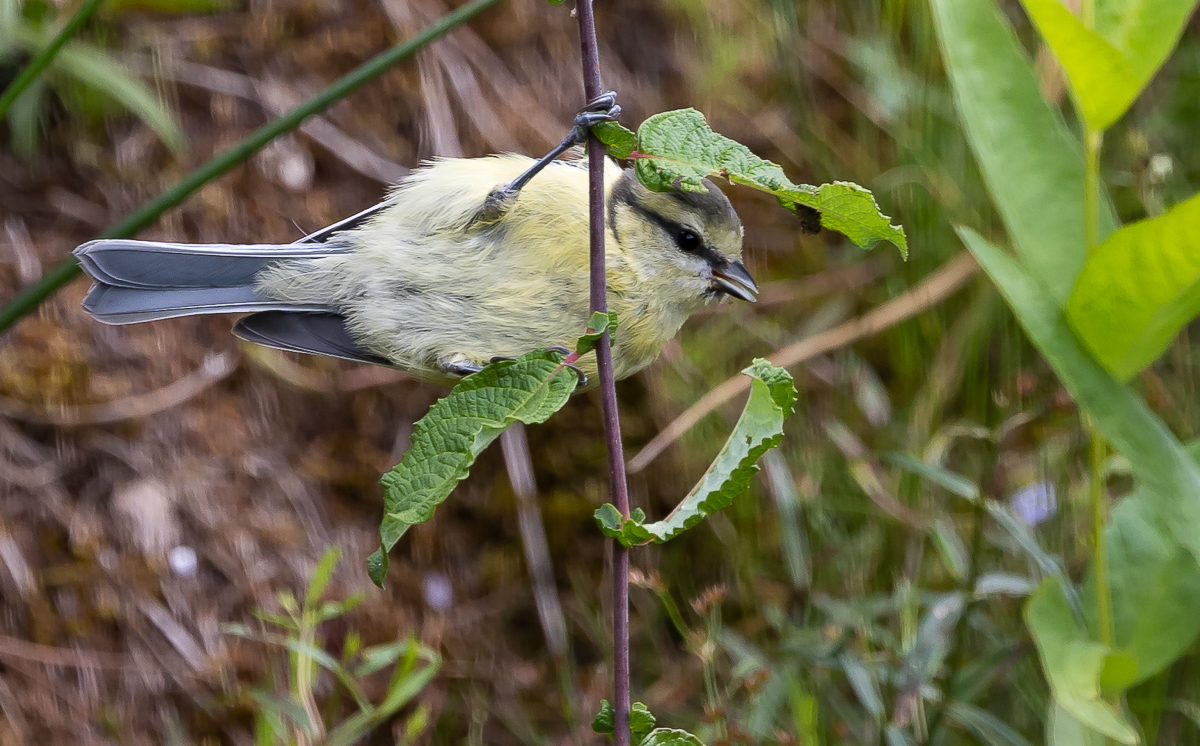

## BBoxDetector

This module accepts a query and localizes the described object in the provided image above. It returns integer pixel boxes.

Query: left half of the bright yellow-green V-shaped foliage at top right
[1021,0,1146,132]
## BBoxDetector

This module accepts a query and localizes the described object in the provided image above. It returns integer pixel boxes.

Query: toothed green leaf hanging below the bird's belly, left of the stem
[367,350,578,586]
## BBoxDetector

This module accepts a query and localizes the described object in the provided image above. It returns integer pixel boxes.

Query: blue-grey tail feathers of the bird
[74,239,344,324]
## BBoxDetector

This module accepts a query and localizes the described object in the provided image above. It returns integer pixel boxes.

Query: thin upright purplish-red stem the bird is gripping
[575,0,630,746]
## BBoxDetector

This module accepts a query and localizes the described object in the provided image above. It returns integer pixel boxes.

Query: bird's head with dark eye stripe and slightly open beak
[608,169,758,314]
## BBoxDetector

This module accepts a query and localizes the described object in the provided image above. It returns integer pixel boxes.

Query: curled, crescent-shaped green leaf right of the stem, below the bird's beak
[595,359,796,547]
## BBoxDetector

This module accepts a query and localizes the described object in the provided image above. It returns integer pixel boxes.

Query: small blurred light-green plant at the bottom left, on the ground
[224,547,442,746]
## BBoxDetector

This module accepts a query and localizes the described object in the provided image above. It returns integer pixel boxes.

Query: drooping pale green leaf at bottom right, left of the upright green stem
[1025,577,1138,746]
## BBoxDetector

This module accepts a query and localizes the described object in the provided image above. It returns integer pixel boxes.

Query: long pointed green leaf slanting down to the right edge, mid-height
[958,227,1200,570]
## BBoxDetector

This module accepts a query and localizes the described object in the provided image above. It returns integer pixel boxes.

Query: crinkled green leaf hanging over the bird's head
[634,109,908,258]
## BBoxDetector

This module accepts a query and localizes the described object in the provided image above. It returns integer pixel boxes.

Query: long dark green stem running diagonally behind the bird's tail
[0,0,499,332]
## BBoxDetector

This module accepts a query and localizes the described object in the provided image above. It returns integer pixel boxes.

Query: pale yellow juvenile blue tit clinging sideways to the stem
[74,155,757,384]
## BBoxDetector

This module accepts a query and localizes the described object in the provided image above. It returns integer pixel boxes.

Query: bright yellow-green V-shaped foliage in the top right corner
[1021,0,1196,131]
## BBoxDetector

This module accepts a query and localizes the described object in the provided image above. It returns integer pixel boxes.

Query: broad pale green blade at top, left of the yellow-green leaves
[931,0,1116,307]
